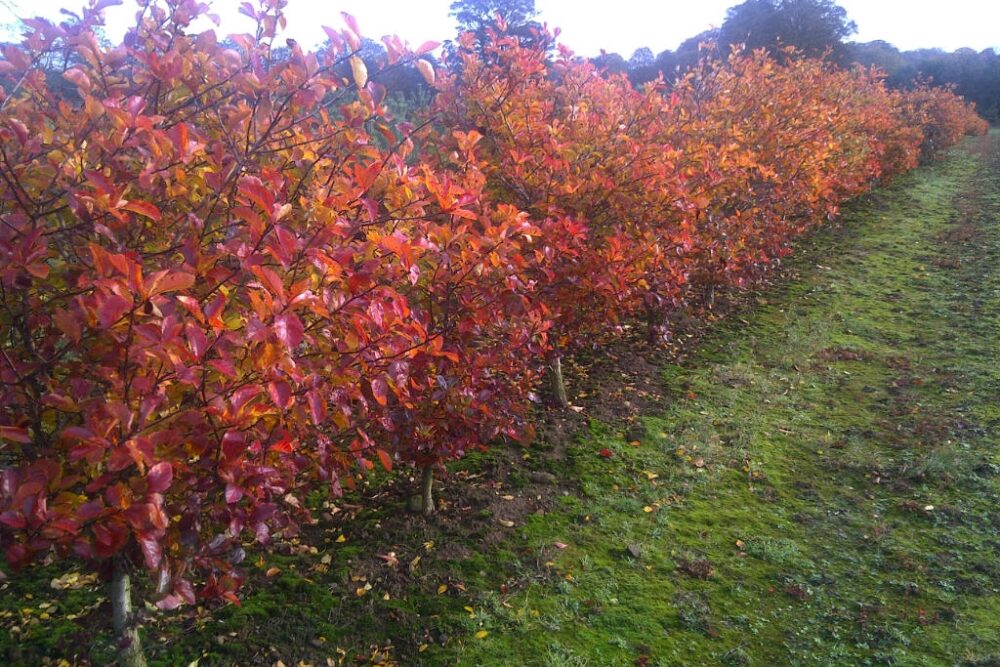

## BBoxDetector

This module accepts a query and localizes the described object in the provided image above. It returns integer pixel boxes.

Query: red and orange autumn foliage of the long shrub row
[0,0,986,632]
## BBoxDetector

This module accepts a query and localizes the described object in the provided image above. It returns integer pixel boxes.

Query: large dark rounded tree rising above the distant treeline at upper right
[719,0,857,61]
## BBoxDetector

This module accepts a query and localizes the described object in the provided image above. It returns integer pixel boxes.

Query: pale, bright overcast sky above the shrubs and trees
[0,0,1000,58]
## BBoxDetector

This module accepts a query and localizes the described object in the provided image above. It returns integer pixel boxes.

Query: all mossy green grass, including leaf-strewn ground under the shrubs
[0,135,1000,667]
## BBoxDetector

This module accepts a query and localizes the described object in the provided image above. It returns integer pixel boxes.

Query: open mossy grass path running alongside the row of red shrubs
[446,133,1000,666]
